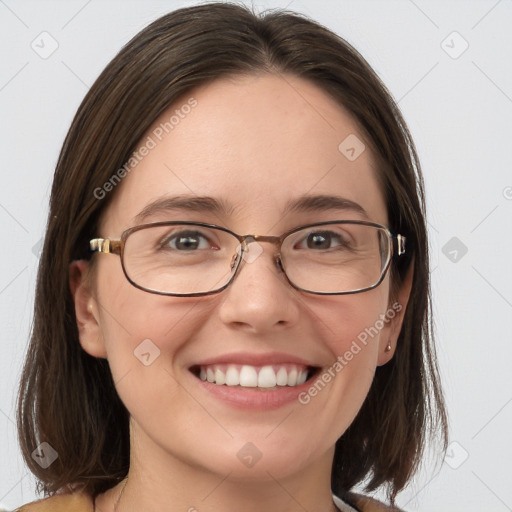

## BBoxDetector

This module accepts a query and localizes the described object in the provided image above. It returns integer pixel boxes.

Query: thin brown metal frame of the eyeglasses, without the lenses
[89,220,406,297]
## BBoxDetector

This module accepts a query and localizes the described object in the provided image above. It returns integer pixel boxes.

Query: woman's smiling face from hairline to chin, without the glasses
[75,74,408,480]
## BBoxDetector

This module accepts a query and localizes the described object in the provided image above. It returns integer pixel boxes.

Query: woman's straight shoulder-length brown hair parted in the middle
[18,3,447,500]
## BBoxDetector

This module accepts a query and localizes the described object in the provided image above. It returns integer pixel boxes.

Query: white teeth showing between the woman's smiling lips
[190,364,320,391]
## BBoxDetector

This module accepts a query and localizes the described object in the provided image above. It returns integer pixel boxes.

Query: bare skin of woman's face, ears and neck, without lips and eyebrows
[70,74,410,512]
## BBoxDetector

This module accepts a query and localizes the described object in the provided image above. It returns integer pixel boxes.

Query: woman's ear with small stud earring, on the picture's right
[377,259,414,366]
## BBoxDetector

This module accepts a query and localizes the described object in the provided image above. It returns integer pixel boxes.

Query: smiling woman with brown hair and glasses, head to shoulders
[15,3,446,512]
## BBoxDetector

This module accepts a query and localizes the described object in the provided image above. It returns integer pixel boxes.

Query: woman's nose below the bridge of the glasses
[219,241,299,333]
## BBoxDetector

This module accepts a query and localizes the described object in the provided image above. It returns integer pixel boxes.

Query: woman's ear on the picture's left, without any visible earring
[69,260,107,358]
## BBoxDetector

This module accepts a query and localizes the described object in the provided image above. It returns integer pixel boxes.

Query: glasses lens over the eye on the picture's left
[123,224,240,295]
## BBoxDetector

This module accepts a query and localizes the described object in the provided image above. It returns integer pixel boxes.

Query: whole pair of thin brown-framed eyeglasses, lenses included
[89,220,405,297]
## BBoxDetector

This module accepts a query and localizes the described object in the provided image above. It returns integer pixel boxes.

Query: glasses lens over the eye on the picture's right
[281,223,391,293]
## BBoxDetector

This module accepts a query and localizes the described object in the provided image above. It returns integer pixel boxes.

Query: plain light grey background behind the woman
[0,0,512,512]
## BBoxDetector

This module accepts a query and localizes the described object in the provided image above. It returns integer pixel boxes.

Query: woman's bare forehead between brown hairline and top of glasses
[102,74,387,233]
